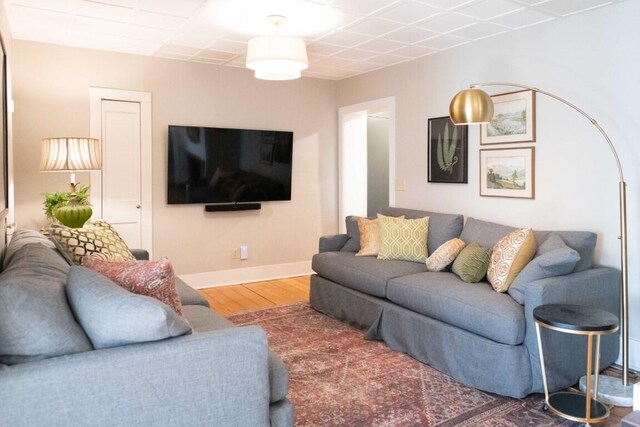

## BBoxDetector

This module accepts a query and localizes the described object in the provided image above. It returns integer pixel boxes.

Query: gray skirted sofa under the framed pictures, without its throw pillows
[310,208,620,398]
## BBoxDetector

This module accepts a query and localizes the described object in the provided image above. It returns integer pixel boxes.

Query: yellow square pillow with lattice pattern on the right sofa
[378,214,429,263]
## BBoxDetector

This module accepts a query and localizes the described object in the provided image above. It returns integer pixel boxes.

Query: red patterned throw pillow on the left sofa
[82,255,182,316]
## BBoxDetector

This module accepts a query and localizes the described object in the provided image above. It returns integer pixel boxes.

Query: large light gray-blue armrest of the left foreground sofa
[0,326,269,426]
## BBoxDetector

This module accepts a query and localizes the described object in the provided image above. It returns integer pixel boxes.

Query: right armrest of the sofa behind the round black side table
[524,267,620,391]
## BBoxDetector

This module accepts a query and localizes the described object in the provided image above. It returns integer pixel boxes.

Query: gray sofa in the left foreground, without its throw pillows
[0,230,293,427]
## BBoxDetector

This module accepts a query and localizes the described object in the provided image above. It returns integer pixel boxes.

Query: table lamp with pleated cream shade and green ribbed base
[40,138,102,228]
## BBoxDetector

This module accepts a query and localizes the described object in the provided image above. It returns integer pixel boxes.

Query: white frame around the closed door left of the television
[89,87,153,257]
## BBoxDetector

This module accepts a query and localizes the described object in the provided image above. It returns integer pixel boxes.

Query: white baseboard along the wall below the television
[180,261,313,289]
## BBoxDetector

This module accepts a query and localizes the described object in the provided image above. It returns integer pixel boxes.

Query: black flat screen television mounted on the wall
[167,125,293,204]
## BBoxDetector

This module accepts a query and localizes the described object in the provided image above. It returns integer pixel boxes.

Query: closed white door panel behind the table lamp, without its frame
[101,100,142,248]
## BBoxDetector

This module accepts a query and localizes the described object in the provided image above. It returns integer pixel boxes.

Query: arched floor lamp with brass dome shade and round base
[449,82,633,406]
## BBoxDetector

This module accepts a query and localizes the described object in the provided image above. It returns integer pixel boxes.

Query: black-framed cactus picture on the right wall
[427,117,469,184]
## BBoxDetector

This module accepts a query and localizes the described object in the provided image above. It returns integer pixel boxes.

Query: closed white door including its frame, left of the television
[90,88,153,254]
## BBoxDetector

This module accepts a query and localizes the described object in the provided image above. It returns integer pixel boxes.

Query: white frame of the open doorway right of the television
[338,96,396,232]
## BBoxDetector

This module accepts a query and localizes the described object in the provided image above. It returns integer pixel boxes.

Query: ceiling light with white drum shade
[247,15,309,80]
